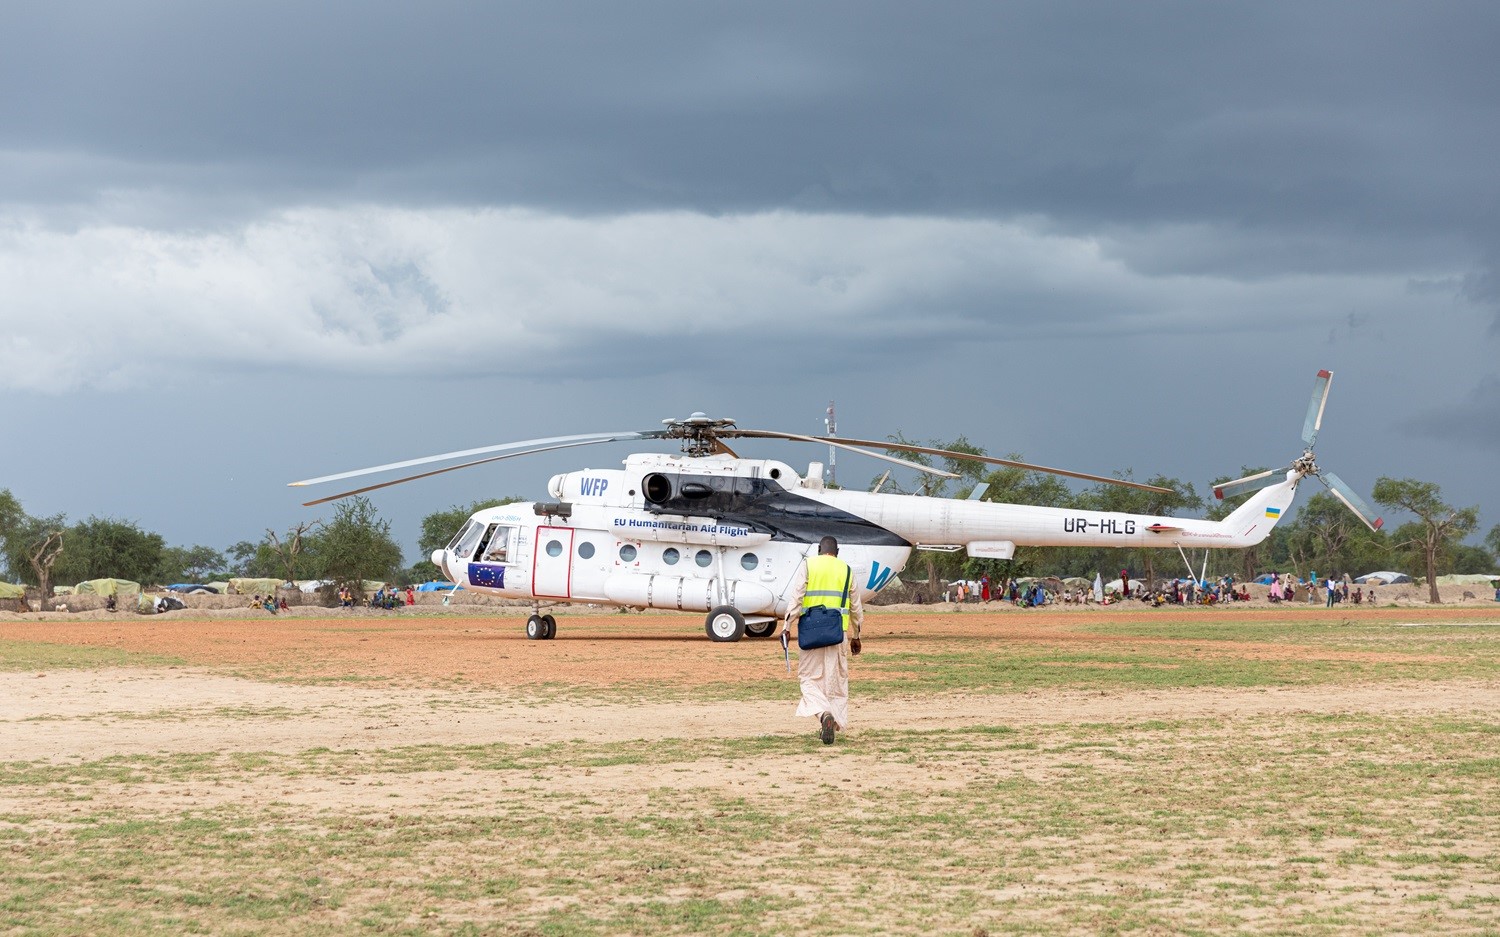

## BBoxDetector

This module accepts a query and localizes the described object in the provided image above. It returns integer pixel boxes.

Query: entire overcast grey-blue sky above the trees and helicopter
[0,0,1500,559]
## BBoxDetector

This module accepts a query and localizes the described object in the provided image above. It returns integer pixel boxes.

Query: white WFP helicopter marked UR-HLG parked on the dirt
[291,370,1382,642]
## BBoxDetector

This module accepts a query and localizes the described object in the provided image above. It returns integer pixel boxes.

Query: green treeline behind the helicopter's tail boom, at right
[882,435,1500,601]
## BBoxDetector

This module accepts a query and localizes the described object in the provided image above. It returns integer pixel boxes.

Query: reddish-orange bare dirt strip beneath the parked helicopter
[0,606,1500,688]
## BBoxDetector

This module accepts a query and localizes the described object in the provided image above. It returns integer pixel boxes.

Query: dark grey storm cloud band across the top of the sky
[0,3,1500,244]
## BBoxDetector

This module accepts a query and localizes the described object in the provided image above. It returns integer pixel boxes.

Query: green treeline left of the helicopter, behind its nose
[0,489,516,594]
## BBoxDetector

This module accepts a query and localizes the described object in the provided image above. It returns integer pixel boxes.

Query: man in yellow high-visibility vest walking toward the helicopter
[786,537,864,745]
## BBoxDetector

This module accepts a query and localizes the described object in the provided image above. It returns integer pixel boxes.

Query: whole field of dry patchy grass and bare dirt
[0,607,1500,934]
